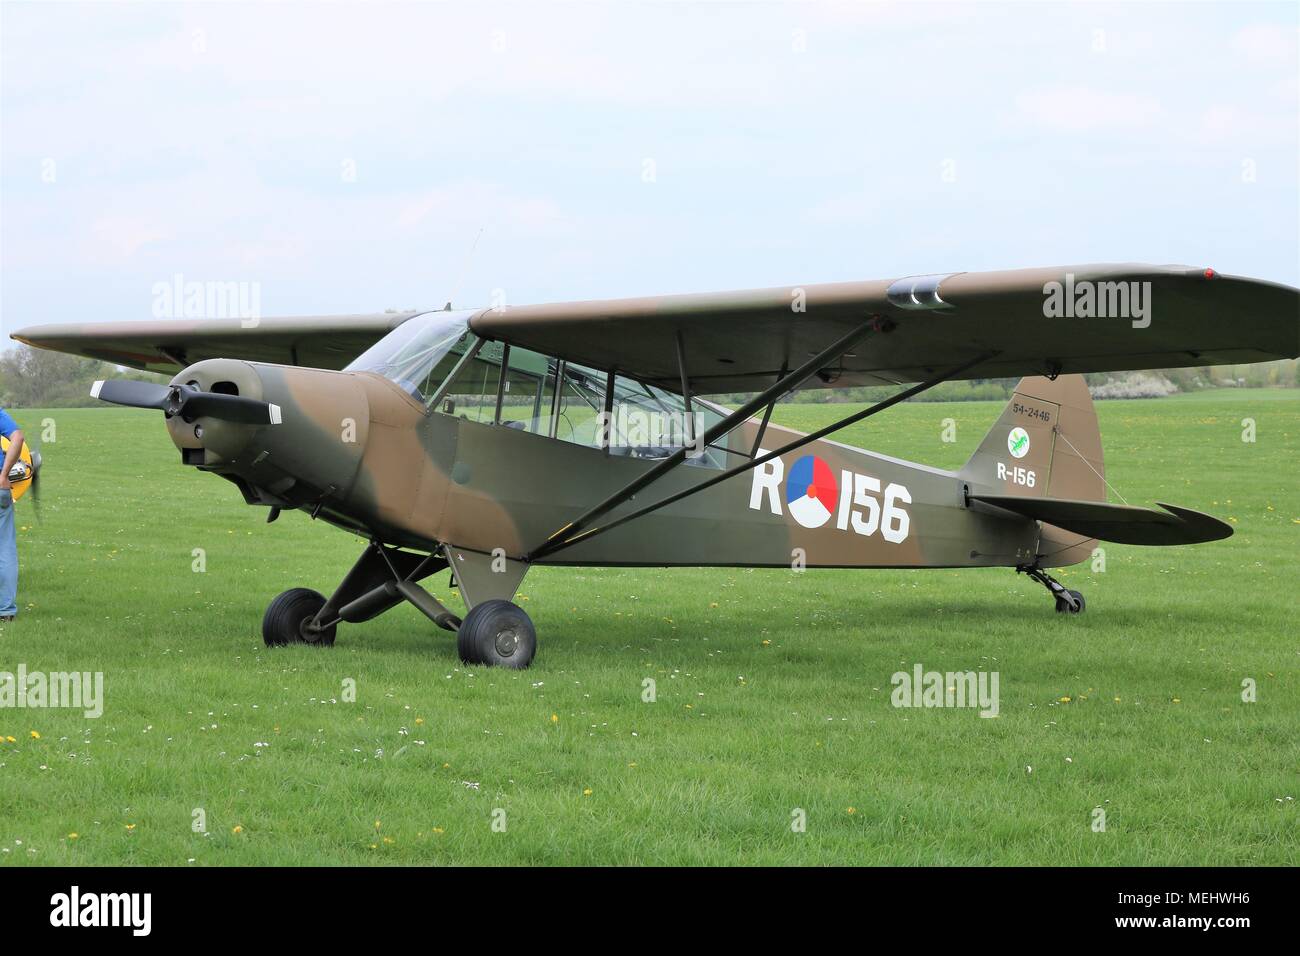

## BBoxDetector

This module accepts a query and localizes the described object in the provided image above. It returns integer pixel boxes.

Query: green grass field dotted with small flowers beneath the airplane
[0,390,1300,866]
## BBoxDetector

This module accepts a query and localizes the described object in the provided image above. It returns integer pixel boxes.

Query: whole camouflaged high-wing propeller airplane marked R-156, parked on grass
[13,264,1300,667]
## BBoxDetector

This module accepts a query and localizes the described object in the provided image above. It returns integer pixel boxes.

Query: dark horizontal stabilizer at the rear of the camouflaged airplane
[971,494,1232,545]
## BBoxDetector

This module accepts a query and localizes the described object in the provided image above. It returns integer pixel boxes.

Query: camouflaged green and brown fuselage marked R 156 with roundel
[168,359,1037,567]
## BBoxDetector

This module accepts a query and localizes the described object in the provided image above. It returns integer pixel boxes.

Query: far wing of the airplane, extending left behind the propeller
[12,312,416,373]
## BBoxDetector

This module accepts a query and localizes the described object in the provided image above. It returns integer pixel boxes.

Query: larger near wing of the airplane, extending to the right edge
[471,265,1300,394]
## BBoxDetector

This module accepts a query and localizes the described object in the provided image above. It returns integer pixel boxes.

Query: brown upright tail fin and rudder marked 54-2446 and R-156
[958,375,1106,566]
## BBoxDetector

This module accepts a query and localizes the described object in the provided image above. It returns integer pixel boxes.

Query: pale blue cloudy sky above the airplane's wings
[0,0,1300,345]
